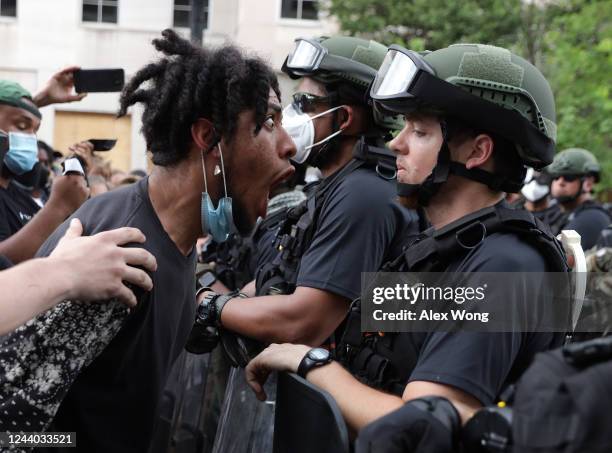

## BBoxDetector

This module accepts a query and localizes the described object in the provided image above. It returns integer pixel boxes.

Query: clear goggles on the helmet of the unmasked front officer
[370,45,436,100]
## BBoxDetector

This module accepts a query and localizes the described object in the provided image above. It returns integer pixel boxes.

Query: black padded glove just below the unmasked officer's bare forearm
[355,396,461,453]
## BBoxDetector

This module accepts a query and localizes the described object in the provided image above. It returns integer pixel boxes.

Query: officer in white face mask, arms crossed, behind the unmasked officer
[187,37,417,365]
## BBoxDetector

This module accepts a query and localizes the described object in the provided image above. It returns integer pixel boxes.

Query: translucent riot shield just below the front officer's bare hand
[213,368,276,453]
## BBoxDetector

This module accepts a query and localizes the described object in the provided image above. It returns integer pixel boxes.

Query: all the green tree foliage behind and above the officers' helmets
[328,0,612,188]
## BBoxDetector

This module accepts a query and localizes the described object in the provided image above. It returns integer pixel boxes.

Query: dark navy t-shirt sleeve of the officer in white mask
[296,167,418,300]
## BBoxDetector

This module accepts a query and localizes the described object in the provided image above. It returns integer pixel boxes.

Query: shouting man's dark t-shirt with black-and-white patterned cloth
[0,178,195,453]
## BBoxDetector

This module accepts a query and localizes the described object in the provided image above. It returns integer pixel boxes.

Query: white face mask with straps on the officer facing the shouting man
[283,104,342,164]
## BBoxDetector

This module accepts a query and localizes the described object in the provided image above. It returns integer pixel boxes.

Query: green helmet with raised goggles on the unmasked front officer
[371,44,556,169]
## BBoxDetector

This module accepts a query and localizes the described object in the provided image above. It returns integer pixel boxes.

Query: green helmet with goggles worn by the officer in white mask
[282,36,401,129]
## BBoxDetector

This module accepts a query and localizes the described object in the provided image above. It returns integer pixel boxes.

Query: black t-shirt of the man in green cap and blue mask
[0,181,40,241]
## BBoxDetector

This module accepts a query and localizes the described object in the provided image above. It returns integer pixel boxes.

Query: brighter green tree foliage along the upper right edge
[544,0,612,189]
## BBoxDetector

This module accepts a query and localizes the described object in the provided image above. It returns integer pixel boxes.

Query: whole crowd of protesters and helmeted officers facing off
[0,30,612,452]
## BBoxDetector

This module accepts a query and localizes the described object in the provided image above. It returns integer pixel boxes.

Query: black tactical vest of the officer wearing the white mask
[255,138,396,296]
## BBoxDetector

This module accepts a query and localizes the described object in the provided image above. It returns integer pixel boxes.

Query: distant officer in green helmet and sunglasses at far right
[547,148,611,250]
